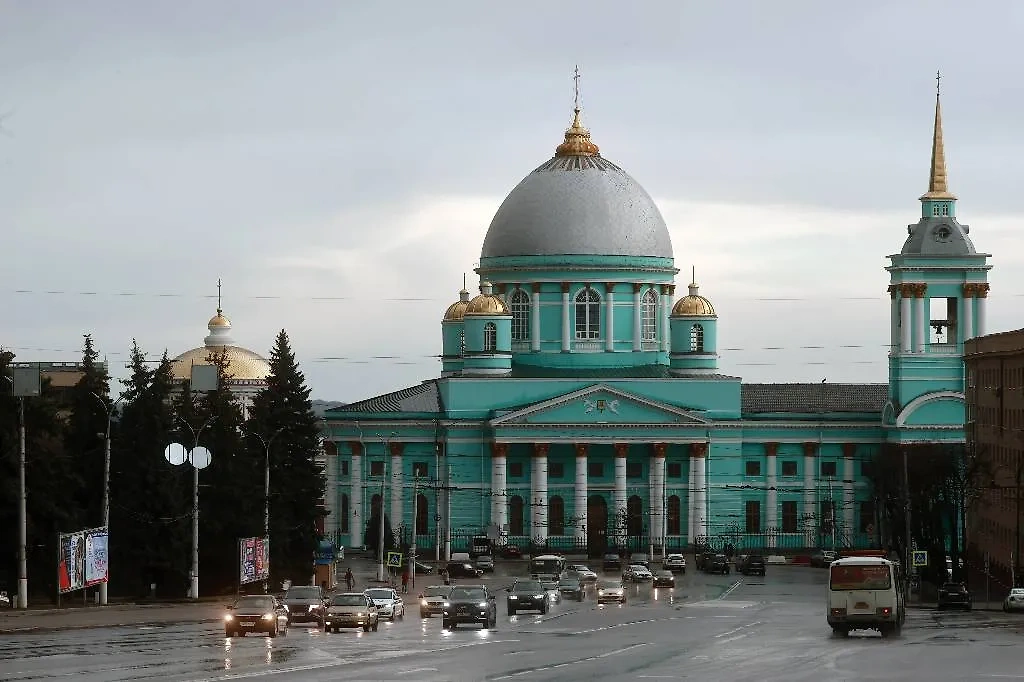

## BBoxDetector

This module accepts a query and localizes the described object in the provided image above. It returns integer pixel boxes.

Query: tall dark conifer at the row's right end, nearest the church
[247,330,325,582]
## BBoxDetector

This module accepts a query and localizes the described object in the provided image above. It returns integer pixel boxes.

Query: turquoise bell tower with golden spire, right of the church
[885,75,991,427]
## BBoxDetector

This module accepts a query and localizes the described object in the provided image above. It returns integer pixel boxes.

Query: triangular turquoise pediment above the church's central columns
[490,384,708,426]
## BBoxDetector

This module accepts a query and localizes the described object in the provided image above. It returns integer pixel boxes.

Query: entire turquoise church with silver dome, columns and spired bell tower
[327,87,989,554]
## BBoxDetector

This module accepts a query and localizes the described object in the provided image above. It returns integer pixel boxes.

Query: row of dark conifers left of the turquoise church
[0,331,325,598]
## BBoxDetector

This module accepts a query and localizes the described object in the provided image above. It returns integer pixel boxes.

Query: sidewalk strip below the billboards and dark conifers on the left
[0,600,227,635]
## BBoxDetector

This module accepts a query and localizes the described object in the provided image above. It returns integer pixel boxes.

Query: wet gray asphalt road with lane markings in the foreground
[0,567,1024,682]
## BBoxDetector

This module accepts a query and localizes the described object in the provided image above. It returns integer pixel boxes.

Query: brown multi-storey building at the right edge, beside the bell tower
[964,330,1024,588]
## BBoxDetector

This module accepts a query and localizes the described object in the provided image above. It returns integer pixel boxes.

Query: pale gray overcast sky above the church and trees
[0,0,1024,400]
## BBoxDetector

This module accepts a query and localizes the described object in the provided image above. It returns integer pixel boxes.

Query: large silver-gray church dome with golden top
[480,113,672,258]
